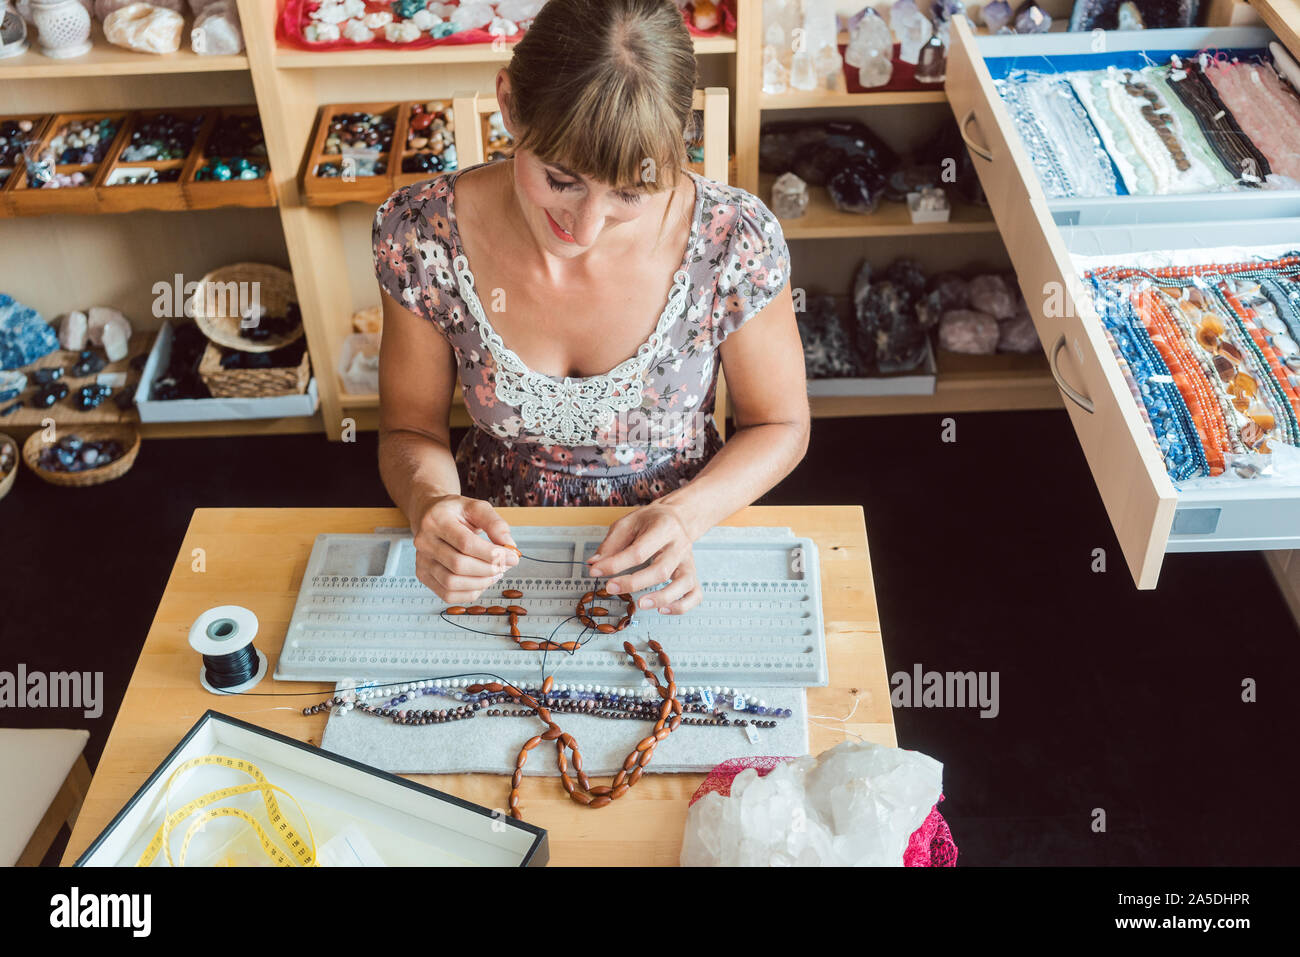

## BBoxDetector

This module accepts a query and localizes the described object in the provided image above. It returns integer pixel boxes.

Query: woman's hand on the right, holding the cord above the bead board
[588,502,705,615]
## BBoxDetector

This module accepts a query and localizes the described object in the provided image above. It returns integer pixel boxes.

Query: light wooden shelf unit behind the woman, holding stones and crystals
[0,0,1058,439]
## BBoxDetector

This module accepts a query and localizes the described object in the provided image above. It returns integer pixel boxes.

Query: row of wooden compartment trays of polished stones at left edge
[0,107,274,216]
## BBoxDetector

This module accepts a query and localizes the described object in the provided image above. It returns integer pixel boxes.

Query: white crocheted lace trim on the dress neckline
[452,255,690,446]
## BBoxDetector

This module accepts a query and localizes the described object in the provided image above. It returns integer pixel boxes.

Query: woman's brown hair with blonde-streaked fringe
[506,0,696,191]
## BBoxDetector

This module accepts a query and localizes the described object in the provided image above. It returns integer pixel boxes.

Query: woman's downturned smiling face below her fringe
[515,150,658,257]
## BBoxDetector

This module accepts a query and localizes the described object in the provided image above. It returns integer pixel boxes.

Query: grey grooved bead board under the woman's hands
[276,525,827,690]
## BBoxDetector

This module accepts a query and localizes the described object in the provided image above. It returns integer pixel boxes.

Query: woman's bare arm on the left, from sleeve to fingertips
[380,291,519,603]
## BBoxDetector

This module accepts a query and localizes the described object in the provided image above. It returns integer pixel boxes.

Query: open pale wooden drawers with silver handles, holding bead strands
[946,18,1300,589]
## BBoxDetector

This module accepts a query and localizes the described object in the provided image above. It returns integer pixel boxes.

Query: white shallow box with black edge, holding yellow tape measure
[77,710,550,867]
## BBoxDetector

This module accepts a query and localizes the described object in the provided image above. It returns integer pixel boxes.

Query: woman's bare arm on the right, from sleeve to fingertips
[589,283,810,614]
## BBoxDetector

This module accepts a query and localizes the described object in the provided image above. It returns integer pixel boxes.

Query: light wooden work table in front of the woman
[64,506,897,865]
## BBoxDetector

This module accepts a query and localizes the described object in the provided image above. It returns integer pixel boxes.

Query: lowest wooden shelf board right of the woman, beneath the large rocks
[809,352,1062,419]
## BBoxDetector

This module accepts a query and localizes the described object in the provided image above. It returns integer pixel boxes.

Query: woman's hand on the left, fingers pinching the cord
[411,495,519,605]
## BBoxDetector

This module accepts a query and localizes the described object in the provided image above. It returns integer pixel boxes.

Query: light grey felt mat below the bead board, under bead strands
[321,686,809,774]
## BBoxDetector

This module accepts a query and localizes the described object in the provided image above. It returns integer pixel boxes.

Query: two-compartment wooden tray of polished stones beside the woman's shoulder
[300,100,456,205]
